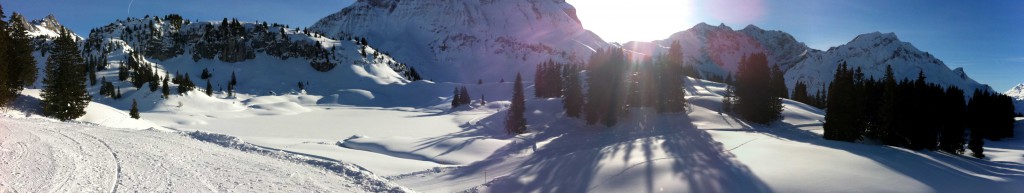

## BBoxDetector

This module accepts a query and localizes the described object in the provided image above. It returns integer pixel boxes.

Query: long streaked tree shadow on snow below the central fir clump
[452,110,771,192]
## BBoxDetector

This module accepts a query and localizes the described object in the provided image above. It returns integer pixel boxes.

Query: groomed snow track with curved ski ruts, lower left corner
[0,116,402,192]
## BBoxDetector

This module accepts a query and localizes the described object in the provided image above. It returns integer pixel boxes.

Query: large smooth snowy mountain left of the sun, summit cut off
[310,0,607,82]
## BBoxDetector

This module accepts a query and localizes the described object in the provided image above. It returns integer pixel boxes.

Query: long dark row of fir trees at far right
[823,63,1014,157]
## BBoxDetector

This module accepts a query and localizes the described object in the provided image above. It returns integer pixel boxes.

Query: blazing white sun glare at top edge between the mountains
[567,0,698,43]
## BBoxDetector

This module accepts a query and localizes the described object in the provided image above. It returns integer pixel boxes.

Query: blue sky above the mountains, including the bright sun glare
[0,0,1024,91]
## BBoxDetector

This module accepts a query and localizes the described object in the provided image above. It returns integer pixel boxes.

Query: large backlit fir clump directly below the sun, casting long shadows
[581,42,689,126]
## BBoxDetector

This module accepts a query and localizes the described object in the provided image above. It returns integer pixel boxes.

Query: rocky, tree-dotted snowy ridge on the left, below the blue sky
[22,15,456,107]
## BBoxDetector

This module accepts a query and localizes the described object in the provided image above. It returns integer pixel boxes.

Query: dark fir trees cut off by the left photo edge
[0,6,38,108]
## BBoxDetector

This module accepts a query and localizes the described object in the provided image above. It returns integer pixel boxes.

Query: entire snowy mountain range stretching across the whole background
[23,0,992,102]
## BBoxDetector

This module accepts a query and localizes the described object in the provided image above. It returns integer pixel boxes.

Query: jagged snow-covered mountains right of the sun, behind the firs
[623,23,991,92]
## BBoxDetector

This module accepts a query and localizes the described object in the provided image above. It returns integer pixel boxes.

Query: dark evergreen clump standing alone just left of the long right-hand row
[734,53,782,124]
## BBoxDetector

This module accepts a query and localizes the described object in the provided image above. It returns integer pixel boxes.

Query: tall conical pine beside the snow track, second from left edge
[40,30,91,121]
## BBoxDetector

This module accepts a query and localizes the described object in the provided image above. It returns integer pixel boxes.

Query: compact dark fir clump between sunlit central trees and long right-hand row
[723,53,787,124]
